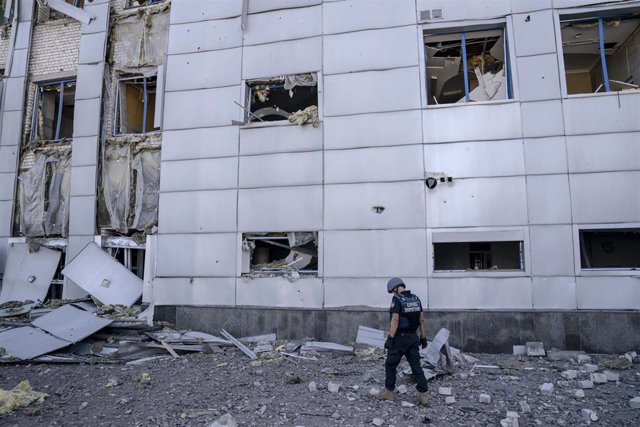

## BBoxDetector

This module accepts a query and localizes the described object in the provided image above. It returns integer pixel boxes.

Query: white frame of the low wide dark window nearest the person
[427,227,531,278]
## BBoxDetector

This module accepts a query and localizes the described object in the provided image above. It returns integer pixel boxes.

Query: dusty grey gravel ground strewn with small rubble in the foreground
[0,348,640,427]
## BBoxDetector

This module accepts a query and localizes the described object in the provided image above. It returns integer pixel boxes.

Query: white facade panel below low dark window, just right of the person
[429,277,532,310]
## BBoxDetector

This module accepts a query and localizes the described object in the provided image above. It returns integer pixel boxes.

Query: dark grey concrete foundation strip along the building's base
[155,306,640,353]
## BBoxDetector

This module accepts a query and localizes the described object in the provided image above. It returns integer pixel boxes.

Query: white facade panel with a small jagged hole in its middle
[324,181,425,230]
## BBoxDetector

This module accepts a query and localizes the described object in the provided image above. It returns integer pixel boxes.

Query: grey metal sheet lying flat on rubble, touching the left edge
[0,326,71,360]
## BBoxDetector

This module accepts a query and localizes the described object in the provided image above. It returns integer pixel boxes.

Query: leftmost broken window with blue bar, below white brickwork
[29,80,76,141]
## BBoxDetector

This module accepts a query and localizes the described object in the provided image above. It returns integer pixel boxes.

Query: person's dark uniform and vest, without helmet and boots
[384,290,428,393]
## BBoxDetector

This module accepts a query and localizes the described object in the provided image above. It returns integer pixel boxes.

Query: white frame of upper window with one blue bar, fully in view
[418,16,519,109]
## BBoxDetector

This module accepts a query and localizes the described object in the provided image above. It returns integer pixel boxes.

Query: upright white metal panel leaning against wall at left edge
[0,243,61,304]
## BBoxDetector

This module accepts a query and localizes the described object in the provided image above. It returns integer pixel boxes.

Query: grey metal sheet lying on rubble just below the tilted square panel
[32,305,112,343]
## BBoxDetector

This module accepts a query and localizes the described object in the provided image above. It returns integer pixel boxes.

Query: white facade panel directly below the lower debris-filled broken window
[237,277,323,308]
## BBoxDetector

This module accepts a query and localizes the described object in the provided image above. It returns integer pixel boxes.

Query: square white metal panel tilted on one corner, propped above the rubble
[62,243,142,306]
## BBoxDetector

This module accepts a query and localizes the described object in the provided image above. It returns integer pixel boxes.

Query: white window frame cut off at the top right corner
[553,3,640,98]
